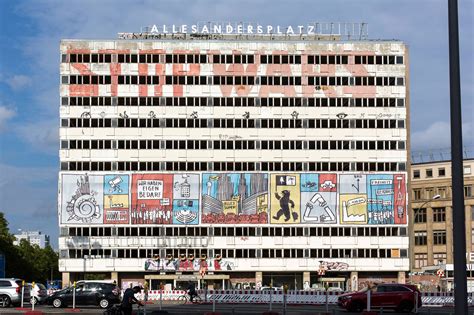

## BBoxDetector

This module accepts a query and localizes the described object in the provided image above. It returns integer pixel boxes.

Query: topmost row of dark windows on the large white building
[62,54,403,65]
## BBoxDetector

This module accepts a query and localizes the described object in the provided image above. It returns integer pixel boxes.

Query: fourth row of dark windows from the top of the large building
[61,118,405,129]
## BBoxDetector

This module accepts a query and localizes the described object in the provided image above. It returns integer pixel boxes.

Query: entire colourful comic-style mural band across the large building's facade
[60,173,407,225]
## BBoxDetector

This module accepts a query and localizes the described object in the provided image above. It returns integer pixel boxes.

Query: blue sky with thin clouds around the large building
[0,0,474,246]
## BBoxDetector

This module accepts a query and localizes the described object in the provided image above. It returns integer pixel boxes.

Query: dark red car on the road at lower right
[337,283,422,313]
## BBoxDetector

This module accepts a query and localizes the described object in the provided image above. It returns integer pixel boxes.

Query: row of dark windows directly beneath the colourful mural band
[65,226,407,237]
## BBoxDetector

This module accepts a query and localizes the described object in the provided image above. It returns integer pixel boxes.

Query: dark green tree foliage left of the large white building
[0,212,60,283]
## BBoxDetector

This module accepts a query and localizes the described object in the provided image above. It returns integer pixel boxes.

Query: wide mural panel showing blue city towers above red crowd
[202,173,268,224]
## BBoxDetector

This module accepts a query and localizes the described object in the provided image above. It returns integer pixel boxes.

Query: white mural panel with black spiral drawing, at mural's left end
[60,174,104,224]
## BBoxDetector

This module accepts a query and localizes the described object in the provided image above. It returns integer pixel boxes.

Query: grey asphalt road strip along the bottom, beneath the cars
[0,304,474,315]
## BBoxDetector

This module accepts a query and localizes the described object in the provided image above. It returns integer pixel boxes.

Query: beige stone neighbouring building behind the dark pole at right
[410,159,474,292]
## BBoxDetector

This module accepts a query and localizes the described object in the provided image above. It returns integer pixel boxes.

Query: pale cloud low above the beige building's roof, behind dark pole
[411,121,474,151]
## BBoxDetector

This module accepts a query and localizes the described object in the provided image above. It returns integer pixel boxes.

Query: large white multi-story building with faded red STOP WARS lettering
[58,23,409,289]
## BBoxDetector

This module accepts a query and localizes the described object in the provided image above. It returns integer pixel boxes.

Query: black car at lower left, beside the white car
[46,282,120,308]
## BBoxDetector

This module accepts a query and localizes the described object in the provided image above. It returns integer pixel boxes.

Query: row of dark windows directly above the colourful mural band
[61,161,406,172]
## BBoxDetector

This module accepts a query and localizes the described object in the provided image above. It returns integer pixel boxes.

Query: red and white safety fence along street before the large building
[140,290,474,306]
